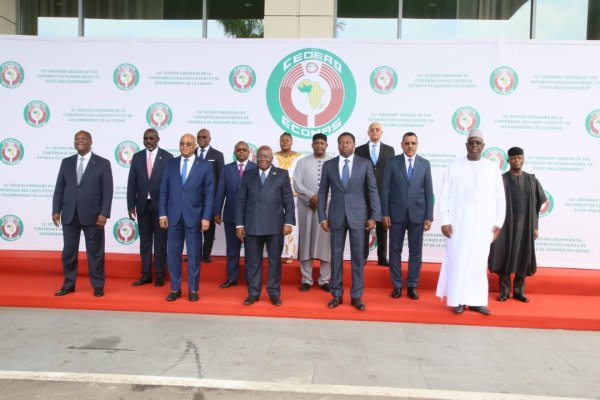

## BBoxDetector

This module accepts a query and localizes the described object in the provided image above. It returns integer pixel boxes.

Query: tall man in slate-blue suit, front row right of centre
[317,132,381,311]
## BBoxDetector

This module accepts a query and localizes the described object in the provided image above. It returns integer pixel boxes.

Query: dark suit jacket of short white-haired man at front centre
[235,166,296,235]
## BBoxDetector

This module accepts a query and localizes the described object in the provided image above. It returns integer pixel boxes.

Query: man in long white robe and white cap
[436,129,506,315]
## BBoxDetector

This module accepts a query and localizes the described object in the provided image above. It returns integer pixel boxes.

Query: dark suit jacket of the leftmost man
[52,153,113,225]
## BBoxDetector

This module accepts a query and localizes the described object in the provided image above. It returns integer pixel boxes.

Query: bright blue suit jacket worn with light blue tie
[159,156,215,228]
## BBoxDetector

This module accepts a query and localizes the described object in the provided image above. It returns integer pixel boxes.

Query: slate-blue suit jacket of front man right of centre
[317,154,381,229]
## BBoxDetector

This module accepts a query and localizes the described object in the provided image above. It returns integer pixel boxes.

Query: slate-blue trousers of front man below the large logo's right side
[329,220,365,299]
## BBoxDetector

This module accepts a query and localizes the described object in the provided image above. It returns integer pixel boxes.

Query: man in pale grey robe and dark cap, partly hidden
[293,133,331,292]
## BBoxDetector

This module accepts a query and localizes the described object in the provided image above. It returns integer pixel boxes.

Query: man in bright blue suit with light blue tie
[159,133,215,301]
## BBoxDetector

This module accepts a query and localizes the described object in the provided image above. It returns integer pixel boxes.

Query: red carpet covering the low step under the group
[0,251,600,330]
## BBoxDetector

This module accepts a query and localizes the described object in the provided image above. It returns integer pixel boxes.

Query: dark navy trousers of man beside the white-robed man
[390,217,423,288]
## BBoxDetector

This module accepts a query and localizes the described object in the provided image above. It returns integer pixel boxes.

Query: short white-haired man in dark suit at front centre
[235,146,296,306]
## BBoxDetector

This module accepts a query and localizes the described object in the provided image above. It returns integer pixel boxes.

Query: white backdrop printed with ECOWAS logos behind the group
[0,36,600,269]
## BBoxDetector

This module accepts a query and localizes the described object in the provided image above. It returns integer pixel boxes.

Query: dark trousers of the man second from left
[138,200,167,278]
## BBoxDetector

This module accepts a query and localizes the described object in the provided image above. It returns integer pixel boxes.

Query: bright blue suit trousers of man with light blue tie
[167,219,202,292]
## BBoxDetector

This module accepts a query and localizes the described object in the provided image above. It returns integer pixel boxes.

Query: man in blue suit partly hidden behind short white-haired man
[214,142,256,289]
